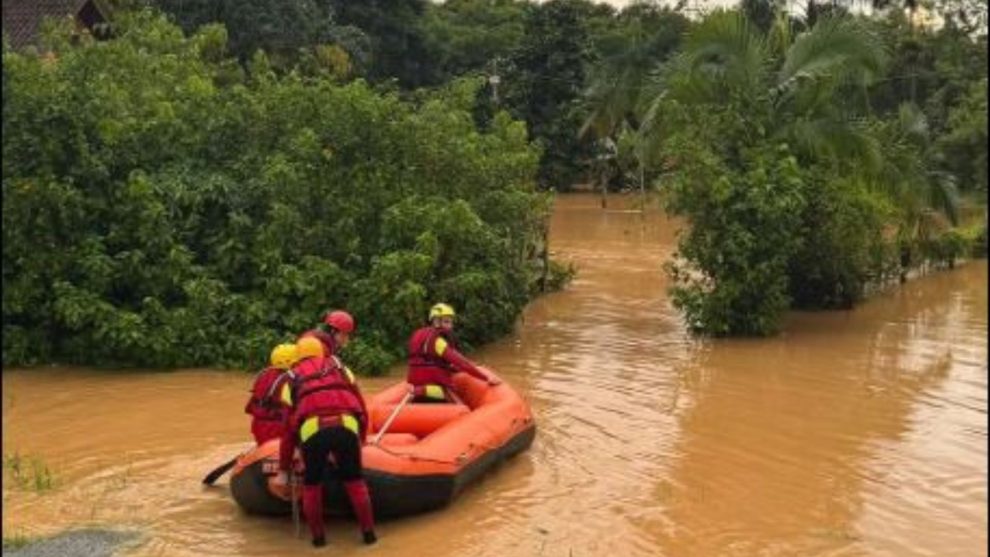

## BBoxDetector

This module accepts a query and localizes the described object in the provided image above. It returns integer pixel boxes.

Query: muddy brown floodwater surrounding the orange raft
[3,195,988,557]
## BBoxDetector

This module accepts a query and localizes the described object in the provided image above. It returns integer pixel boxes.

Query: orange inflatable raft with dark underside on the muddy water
[230,370,536,517]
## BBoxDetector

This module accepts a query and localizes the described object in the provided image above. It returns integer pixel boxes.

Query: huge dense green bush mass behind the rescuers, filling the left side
[3,11,549,373]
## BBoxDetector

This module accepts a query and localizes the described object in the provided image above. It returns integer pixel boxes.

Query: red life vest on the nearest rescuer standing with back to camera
[283,356,367,443]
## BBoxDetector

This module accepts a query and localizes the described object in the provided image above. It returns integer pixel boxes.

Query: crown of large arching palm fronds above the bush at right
[644,11,886,166]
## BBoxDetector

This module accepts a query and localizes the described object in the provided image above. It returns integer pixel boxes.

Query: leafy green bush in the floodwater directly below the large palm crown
[669,145,805,335]
